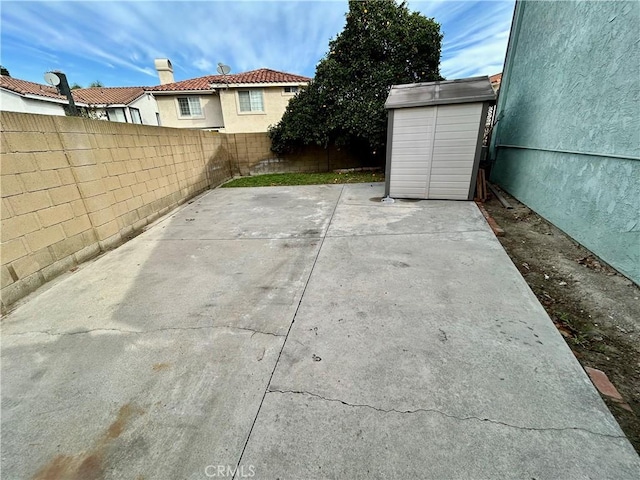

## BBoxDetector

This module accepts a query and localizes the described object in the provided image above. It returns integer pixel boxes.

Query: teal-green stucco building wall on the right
[491,1,640,284]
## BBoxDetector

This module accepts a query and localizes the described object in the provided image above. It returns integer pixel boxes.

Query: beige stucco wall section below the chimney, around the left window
[154,92,224,128]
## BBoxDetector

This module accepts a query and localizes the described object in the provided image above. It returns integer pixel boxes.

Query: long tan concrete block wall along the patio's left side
[0,112,232,310]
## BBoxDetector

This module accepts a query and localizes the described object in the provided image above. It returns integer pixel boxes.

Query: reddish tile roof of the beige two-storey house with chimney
[147,68,311,92]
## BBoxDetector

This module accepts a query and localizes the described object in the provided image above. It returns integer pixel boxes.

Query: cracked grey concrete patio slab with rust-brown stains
[1,184,640,479]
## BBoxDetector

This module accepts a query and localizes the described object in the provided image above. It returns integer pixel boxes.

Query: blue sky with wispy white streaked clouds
[0,0,514,86]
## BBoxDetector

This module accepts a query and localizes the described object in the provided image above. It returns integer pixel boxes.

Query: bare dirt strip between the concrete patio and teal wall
[484,188,640,453]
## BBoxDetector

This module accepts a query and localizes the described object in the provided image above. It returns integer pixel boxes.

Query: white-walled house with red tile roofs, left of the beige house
[0,75,159,125]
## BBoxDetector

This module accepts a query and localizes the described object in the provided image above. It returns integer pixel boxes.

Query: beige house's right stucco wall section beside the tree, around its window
[220,87,294,133]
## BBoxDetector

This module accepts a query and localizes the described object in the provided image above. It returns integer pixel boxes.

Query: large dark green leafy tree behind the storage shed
[269,0,442,159]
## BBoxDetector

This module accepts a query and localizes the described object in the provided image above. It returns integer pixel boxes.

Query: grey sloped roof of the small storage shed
[384,77,496,109]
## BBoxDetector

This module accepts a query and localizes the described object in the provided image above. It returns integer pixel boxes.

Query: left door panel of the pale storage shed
[389,107,436,198]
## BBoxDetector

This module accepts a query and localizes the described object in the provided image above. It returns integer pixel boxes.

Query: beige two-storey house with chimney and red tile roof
[148,59,311,133]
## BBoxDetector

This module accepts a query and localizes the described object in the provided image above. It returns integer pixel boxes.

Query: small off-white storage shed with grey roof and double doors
[385,77,496,200]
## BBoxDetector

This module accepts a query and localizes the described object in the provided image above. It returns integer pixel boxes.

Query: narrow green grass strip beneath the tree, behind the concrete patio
[222,172,384,188]
